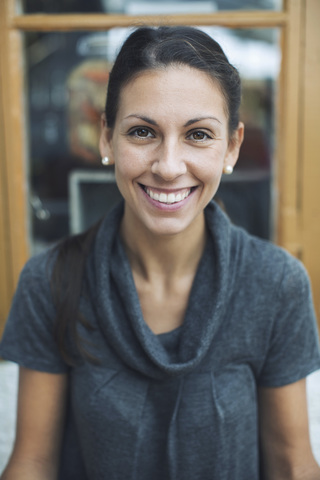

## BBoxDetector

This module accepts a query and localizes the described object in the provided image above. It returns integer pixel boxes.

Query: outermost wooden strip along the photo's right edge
[299,0,320,322]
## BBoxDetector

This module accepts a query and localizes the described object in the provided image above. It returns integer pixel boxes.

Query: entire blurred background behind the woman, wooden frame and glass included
[0,0,320,472]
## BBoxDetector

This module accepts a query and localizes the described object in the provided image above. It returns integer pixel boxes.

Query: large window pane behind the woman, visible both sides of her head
[25,27,280,253]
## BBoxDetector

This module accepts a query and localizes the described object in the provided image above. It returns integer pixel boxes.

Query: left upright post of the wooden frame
[0,0,28,334]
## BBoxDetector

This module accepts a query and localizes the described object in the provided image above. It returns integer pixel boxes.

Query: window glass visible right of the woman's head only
[208,28,281,239]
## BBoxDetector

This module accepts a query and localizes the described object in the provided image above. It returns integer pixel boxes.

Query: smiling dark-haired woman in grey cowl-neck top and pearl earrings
[1,27,320,480]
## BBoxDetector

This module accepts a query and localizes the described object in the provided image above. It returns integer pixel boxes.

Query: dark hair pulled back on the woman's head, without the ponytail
[105,26,241,137]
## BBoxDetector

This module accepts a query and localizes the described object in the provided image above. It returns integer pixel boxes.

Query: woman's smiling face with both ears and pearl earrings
[100,66,243,239]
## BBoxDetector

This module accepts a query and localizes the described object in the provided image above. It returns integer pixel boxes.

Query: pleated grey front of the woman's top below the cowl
[72,354,258,480]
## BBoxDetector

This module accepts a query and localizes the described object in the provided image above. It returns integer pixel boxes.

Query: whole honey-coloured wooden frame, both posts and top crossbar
[0,0,320,334]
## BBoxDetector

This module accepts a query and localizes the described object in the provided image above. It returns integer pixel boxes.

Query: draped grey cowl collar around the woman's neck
[91,202,232,379]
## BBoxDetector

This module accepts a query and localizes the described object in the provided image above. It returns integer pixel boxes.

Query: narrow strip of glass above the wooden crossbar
[23,0,283,15]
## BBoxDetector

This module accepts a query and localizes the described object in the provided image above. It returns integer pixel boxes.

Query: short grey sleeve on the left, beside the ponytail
[0,254,68,373]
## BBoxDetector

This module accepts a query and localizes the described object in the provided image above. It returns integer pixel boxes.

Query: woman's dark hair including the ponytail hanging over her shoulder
[51,27,241,365]
